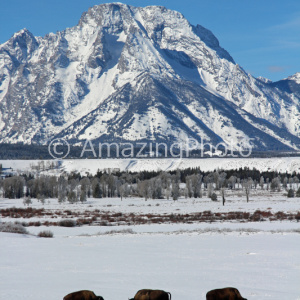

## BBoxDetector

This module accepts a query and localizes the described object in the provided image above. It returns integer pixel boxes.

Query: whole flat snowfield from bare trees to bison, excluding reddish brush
[0,196,300,300]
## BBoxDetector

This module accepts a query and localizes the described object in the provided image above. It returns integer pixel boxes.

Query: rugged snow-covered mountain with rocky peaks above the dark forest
[0,3,300,150]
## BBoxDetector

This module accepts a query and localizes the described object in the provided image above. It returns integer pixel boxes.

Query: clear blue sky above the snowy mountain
[0,0,300,81]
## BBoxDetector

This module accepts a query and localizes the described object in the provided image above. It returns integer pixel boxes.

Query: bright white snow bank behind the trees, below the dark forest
[0,157,300,175]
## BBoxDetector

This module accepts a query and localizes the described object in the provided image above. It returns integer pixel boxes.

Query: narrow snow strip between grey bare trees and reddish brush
[0,191,300,217]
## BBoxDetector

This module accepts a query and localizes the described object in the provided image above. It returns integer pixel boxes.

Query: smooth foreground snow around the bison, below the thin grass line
[0,229,300,300]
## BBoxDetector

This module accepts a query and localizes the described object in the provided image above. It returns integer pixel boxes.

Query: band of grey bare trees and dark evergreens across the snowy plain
[0,168,300,205]
